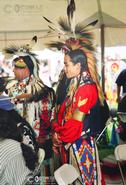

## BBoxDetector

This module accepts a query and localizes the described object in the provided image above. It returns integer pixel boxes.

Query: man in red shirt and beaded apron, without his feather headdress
[53,49,104,185]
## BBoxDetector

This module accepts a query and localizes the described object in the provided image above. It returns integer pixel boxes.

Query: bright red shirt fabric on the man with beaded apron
[53,84,98,143]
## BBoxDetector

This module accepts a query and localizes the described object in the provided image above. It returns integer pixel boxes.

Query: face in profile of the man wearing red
[64,55,80,78]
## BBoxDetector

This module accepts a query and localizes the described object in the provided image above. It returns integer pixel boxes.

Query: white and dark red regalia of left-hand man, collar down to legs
[8,77,55,182]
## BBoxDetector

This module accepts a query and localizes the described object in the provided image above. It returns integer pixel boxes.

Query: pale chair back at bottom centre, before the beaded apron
[54,164,79,185]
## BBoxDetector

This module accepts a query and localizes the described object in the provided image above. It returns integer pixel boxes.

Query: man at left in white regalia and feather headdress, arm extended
[4,38,55,149]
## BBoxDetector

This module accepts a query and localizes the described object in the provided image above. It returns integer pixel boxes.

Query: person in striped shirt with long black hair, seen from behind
[0,109,38,185]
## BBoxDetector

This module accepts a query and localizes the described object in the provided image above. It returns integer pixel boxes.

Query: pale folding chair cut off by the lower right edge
[114,144,126,185]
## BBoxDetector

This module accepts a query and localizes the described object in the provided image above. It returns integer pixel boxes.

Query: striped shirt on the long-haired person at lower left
[0,139,30,185]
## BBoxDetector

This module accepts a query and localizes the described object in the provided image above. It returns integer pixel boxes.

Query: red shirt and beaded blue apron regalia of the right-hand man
[53,72,102,185]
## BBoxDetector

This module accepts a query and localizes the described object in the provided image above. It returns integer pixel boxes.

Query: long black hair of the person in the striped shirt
[0,109,38,171]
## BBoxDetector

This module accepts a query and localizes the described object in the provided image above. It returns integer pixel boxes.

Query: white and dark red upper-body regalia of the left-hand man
[8,76,54,143]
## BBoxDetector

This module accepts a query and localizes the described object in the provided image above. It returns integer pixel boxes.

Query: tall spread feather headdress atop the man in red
[44,0,98,54]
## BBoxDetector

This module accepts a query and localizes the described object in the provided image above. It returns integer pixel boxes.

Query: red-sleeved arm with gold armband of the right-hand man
[54,84,98,143]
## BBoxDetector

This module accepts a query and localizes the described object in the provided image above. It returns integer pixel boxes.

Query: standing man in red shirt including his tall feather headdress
[44,0,105,185]
